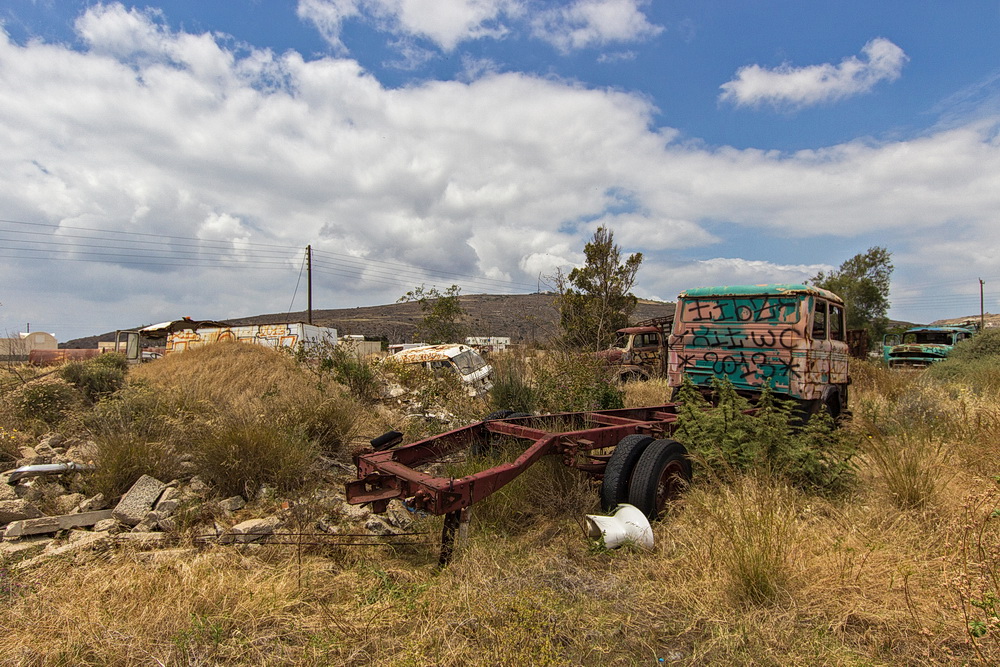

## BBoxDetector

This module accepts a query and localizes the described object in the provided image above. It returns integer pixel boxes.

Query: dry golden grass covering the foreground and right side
[0,350,1000,666]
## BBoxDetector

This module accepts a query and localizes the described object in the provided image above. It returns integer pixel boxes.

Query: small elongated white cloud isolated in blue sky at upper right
[719,37,909,108]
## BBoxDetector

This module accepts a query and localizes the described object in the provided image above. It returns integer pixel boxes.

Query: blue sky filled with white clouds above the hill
[0,0,1000,341]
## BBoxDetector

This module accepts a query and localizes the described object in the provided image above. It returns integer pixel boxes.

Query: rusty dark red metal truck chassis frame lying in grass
[346,403,678,516]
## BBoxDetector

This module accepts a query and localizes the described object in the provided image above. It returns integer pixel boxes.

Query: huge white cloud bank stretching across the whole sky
[0,5,1000,338]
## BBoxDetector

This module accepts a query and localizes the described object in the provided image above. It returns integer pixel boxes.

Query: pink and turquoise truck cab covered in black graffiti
[667,284,850,417]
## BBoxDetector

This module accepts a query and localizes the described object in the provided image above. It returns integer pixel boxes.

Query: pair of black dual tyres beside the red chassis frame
[601,434,691,521]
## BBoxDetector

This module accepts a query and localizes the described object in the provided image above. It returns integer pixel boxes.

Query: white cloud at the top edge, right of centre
[532,0,663,52]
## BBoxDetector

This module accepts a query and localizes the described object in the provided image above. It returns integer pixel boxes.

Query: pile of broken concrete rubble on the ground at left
[0,434,412,568]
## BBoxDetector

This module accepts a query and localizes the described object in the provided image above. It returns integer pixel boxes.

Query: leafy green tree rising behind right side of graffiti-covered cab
[809,246,893,340]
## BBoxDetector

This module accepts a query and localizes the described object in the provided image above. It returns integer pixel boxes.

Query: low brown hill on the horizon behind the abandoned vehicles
[59,292,674,348]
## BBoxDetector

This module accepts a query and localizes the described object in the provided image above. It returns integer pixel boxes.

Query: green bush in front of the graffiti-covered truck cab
[674,382,855,492]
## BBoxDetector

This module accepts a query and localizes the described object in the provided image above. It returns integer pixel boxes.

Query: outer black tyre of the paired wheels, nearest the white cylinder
[628,440,691,521]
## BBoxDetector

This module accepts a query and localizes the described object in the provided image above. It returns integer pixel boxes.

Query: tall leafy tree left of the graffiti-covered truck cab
[556,226,642,349]
